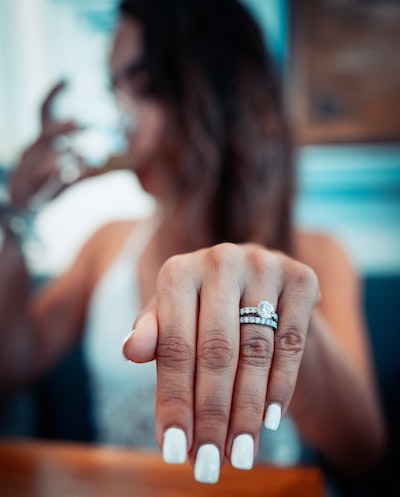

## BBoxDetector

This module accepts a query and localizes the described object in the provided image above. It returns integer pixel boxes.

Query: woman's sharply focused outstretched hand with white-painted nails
[124,243,319,483]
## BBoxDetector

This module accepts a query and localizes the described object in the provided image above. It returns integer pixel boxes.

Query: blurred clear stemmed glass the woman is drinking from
[28,83,136,213]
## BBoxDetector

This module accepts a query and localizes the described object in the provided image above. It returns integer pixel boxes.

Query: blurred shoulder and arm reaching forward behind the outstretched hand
[290,235,385,473]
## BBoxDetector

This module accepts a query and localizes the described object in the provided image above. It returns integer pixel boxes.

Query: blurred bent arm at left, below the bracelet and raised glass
[0,223,99,392]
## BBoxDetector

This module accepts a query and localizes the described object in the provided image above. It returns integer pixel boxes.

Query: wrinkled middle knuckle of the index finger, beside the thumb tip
[157,335,194,369]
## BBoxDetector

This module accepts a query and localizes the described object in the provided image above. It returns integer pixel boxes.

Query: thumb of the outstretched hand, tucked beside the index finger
[122,300,158,362]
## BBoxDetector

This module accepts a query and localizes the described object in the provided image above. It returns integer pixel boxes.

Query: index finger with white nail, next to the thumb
[156,256,198,462]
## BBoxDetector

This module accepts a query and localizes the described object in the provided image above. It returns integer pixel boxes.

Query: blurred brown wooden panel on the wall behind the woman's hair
[286,0,400,145]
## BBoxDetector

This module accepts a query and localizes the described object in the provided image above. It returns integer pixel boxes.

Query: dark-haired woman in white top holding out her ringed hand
[0,0,384,483]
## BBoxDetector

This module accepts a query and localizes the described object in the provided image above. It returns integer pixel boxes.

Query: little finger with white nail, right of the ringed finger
[265,263,318,430]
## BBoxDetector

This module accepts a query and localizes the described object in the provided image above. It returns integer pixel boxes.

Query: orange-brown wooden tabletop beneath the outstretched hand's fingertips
[0,439,325,497]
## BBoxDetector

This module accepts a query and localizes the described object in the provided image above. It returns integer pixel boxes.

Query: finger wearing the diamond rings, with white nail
[226,252,280,469]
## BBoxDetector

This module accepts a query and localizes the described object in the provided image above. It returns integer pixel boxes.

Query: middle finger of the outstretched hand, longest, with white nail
[190,245,240,482]
